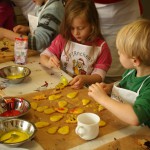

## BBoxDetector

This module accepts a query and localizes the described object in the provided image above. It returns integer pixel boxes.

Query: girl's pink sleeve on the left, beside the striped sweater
[48,34,65,59]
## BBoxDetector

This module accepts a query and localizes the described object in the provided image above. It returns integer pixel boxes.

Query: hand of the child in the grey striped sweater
[13,25,30,34]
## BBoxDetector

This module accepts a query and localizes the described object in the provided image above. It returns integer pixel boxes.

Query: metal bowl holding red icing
[0,97,31,120]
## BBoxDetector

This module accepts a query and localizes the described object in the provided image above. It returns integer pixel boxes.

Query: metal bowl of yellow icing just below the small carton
[0,65,31,84]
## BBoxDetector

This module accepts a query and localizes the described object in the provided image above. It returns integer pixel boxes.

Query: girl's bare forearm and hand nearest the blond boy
[69,74,102,89]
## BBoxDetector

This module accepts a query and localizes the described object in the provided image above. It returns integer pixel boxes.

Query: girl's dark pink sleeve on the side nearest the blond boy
[94,43,112,72]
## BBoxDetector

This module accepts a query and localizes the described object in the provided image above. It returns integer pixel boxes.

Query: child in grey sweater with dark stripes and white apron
[0,0,64,52]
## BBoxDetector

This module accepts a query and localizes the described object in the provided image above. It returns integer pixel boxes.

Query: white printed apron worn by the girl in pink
[61,42,101,76]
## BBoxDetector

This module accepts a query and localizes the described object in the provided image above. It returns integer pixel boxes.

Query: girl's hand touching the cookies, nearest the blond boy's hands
[69,75,85,89]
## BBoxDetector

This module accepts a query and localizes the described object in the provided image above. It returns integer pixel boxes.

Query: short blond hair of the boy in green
[116,19,150,66]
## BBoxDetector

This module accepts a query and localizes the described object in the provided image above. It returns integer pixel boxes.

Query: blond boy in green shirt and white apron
[88,19,150,127]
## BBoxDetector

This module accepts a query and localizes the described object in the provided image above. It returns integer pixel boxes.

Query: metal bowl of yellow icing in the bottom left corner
[0,118,37,147]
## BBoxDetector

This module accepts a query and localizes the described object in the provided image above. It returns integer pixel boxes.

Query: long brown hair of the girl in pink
[60,0,102,41]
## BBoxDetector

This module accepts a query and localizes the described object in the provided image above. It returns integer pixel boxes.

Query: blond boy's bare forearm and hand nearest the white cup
[88,83,139,125]
